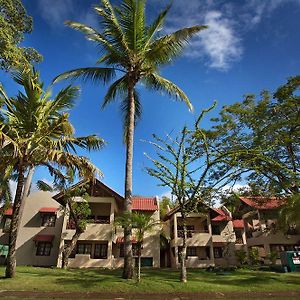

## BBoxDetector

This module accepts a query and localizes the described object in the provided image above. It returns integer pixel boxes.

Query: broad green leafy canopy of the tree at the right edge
[210,76,300,196]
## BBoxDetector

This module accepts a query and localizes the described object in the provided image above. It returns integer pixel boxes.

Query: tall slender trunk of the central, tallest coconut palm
[123,83,135,279]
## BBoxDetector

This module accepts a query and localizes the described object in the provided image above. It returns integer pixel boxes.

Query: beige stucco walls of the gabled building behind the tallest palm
[58,197,161,268]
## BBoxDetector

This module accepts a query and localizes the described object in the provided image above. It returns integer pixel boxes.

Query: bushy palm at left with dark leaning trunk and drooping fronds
[0,70,104,277]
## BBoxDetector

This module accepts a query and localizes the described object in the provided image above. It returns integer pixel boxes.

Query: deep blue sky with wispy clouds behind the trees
[1,0,300,195]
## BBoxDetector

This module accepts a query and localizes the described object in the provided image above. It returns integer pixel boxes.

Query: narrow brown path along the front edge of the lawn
[0,291,300,300]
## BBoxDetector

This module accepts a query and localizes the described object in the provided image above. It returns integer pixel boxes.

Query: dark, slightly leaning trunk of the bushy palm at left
[5,165,25,278]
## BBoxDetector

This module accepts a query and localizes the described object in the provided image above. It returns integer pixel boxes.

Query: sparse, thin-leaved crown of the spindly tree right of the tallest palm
[146,105,246,215]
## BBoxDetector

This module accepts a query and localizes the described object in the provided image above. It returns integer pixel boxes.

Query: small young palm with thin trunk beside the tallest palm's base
[115,212,160,282]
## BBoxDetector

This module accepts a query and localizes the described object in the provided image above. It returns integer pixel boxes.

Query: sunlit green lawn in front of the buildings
[0,267,300,293]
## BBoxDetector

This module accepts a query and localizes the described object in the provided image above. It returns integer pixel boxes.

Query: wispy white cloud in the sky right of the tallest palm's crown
[152,0,300,70]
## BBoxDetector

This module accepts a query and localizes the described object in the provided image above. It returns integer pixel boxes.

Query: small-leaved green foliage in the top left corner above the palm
[0,0,42,70]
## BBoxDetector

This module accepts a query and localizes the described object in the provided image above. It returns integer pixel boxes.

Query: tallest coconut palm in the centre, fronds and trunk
[54,0,206,278]
